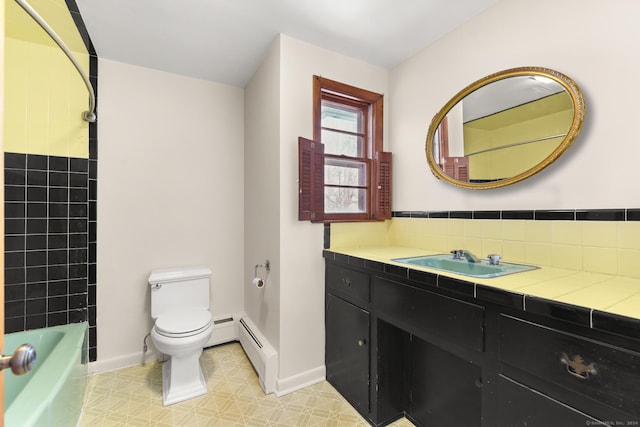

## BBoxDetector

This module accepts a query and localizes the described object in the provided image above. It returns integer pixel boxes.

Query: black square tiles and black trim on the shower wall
[4,0,98,361]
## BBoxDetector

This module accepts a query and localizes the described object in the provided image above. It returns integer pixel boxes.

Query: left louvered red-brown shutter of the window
[298,137,324,222]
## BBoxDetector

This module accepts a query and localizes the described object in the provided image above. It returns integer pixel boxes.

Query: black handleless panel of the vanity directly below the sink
[372,277,484,351]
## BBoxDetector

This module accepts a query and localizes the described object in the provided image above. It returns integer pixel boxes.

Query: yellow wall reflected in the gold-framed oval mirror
[464,93,573,180]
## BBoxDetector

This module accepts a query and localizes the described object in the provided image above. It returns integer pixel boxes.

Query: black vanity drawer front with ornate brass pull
[500,315,640,417]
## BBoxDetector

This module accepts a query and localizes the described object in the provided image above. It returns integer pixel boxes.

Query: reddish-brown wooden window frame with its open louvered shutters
[298,76,391,222]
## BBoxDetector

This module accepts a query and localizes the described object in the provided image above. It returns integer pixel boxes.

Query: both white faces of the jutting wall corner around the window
[245,35,388,394]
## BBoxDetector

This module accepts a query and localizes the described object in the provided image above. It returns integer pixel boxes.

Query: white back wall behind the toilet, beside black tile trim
[97,60,244,370]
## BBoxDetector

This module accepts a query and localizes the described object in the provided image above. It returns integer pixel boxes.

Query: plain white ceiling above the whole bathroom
[76,0,497,87]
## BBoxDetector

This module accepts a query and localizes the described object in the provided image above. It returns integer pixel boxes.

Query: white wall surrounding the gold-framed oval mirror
[387,0,640,210]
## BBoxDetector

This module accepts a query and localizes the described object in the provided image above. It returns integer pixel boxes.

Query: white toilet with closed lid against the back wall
[149,267,213,406]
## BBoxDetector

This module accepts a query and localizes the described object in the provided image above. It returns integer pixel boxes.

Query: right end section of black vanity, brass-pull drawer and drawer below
[497,314,640,427]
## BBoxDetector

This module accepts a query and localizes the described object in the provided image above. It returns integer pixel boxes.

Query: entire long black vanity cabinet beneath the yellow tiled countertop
[325,252,640,427]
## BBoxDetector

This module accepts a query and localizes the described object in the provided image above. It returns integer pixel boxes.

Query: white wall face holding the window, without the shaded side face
[280,36,388,388]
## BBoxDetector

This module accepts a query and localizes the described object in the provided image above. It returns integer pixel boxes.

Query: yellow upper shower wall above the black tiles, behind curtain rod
[4,0,89,158]
